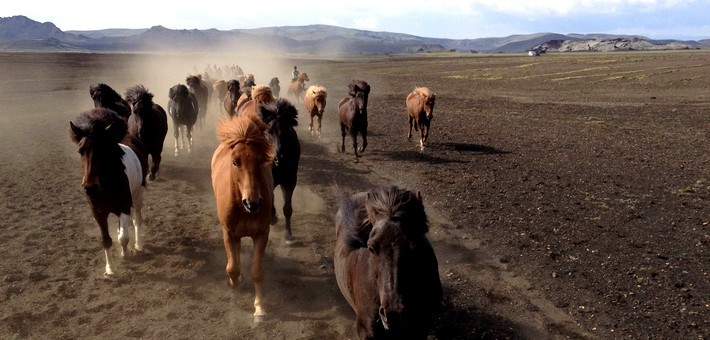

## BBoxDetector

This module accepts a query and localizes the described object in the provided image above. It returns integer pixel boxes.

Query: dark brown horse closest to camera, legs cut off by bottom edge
[333,187,443,339]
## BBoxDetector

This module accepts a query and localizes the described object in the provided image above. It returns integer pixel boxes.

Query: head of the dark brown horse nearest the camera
[365,187,428,330]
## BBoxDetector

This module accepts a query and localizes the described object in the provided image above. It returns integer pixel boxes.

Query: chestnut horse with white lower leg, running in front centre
[211,113,275,322]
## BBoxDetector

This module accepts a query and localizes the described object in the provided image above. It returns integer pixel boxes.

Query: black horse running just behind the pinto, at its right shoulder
[126,85,168,181]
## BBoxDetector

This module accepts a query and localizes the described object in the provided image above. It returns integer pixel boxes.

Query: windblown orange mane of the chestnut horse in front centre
[217,115,276,162]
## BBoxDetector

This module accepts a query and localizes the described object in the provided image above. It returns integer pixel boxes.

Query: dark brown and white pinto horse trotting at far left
[69,108,147,275]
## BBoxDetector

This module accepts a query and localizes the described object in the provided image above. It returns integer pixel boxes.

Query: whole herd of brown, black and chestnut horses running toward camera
[70,73,443,339]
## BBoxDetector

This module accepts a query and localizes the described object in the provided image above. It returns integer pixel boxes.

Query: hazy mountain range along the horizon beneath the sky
[0,16,710,54]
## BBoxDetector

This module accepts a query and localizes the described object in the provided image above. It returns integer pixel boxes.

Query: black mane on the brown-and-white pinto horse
[69,107,128,144]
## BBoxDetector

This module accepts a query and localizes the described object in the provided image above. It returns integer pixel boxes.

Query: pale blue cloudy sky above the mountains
[0,0,710,40]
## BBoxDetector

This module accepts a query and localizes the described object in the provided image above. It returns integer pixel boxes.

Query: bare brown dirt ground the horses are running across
[0,52,710,339]
